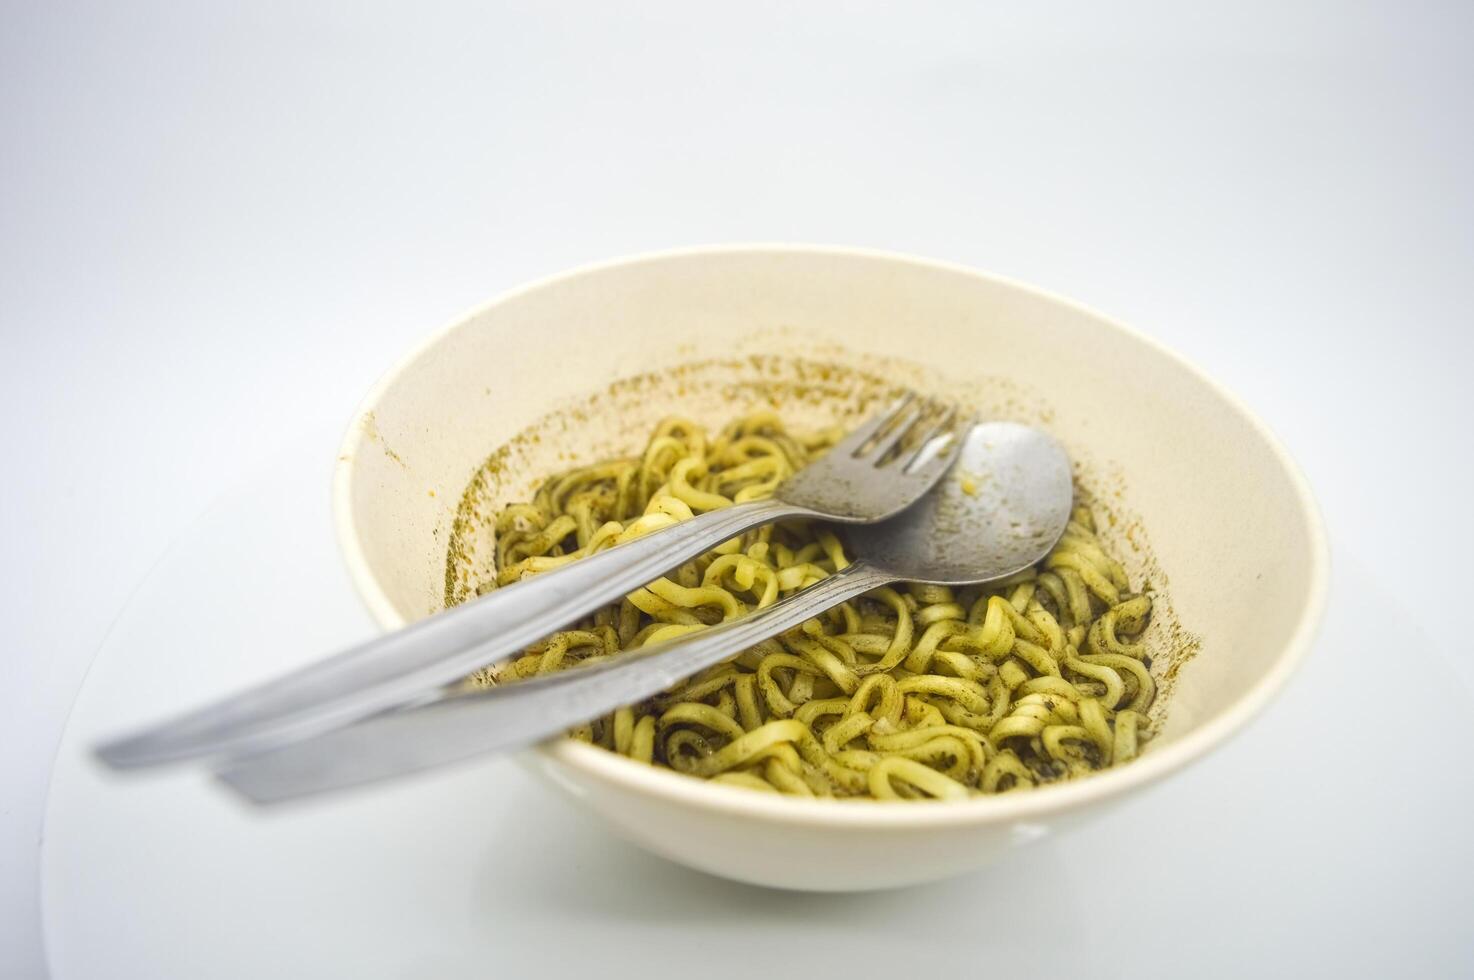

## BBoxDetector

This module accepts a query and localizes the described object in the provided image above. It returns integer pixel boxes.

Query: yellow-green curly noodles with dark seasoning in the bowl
[469,413,1157,800]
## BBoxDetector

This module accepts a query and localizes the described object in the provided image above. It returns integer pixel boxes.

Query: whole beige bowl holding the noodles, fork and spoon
[335,246,1327,890]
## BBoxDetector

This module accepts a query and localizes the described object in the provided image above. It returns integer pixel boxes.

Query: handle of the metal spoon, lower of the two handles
[217,561,895,805]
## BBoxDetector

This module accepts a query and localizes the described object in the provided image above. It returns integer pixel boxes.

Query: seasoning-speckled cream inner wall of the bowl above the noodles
[338,248,1324,778]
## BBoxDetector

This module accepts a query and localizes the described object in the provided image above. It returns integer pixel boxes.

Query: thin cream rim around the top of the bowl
[332,243,1330,830]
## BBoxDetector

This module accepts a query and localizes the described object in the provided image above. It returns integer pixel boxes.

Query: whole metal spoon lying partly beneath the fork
[217,423,1073,803]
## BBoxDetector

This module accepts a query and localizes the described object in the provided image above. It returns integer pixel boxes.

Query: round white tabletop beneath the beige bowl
[43,427,1474,980]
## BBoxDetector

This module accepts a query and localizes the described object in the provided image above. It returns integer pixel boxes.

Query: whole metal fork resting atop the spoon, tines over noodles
[97,395,955,768]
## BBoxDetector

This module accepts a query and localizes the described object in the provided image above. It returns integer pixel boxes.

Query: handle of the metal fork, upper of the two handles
[97,500,820,768]
